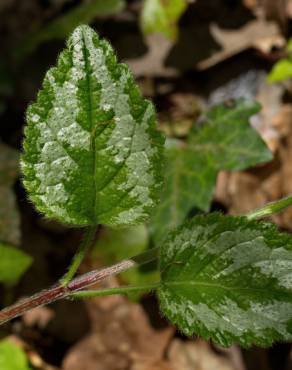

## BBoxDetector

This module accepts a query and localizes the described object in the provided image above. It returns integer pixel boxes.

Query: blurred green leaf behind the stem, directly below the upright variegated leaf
[92,225,159,285]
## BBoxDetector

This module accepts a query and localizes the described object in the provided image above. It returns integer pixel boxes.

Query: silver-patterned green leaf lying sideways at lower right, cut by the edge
[158,214,292,347]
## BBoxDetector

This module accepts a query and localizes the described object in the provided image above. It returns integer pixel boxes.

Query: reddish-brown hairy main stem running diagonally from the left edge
[0,248,159,325]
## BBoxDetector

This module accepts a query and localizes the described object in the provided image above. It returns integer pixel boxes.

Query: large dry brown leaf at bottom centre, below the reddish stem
[63,296,173,370]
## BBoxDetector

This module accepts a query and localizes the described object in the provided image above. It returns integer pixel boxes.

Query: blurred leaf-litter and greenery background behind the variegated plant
[0,0,292,370]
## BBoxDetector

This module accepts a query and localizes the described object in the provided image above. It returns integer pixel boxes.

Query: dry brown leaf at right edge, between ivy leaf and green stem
[215,100,292,230]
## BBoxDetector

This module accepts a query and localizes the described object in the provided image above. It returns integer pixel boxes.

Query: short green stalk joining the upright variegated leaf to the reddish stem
[60,226,96,286]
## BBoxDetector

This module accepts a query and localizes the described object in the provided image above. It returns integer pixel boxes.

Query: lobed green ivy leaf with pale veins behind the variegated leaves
[151,99,272,241]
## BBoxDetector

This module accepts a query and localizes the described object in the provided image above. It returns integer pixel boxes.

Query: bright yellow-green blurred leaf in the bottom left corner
[0,339,31,370]
